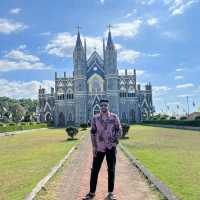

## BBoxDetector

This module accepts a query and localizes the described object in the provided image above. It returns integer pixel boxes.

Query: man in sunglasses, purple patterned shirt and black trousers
[83,99,122,200]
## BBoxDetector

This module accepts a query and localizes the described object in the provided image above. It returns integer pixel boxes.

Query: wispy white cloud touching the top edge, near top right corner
[164,0,199,16]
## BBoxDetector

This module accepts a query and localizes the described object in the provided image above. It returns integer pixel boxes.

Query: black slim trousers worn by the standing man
[90,147,117,193]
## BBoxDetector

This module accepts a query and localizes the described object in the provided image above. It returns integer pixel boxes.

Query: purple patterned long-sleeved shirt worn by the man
[91,112,122,152]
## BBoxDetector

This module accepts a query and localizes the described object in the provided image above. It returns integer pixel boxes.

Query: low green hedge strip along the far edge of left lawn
[0,123,47,133]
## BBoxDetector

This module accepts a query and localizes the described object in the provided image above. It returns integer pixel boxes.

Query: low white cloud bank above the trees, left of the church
[0,79,54,99]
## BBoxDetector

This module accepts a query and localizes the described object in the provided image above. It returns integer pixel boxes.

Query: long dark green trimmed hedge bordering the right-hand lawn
[142,119,200,127]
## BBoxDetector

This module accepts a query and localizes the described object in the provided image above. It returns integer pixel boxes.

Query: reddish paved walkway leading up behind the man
[37,135,159,200]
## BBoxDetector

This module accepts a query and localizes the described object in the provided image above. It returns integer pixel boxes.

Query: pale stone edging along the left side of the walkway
[25,134,86,200]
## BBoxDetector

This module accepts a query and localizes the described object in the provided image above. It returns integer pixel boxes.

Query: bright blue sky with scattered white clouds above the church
[0,0,200,113]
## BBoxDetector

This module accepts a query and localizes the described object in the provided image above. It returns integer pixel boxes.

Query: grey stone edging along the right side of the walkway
[119,143,179,200]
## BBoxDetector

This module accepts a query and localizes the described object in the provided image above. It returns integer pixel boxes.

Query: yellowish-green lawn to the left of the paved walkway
[0,129,87,200]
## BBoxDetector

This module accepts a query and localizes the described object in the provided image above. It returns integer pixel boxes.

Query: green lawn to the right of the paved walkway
[120,125,200,200]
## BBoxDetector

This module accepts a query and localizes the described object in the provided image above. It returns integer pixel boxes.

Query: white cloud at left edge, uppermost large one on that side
[0,18,28,34]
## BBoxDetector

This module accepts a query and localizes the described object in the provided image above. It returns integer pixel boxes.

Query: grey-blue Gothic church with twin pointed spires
[37,30,154,126]
